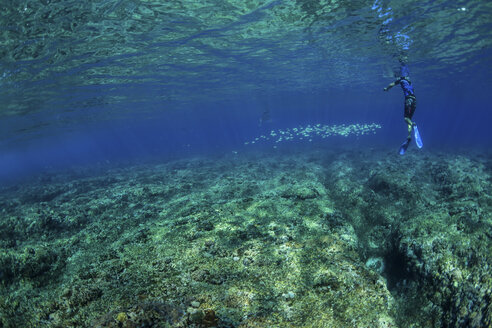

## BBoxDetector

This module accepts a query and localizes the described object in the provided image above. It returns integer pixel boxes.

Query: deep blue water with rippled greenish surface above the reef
[0,0,492,183]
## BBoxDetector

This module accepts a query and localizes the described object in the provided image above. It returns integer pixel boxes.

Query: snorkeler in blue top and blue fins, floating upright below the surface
[383,63,420,155]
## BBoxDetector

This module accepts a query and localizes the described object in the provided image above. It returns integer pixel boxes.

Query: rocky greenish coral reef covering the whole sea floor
[0,151,492,327]
